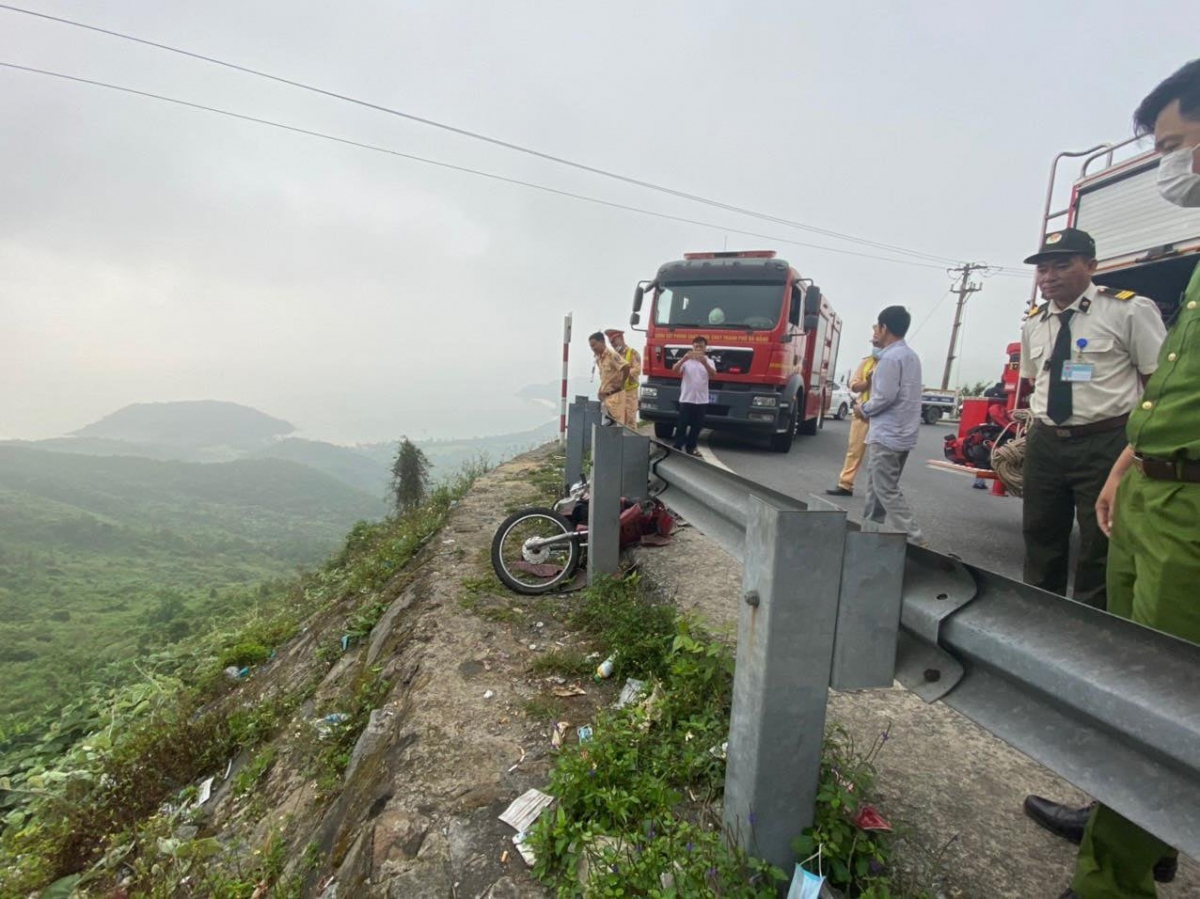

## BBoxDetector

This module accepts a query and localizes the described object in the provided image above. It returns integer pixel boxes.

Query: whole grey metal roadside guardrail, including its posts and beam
[568,398,1200,865]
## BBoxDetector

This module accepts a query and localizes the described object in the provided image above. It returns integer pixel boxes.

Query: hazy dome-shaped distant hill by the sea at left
[72,400,295,450]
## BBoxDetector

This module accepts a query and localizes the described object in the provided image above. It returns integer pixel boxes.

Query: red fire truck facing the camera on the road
[630,250,841,453]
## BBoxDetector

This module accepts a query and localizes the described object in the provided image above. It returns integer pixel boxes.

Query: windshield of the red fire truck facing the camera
[654,281,784,331]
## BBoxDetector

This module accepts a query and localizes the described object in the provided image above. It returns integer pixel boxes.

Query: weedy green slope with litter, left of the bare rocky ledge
[0,458,487,899]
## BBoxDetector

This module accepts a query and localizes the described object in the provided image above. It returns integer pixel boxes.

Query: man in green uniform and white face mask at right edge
[1062,59,1200,899]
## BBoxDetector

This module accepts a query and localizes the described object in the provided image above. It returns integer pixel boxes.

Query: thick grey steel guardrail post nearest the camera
[725,496,846,870]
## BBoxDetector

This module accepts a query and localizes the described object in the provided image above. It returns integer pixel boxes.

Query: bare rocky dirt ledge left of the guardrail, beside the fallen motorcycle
[202,450,562,899]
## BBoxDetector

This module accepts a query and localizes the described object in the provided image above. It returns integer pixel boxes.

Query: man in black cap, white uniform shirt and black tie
[1021,228,1166,609]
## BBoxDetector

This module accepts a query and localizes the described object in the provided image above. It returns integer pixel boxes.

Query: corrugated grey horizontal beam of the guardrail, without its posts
[652,432,1200,857]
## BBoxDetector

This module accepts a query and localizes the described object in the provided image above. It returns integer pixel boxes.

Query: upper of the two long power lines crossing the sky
[0,4,956,264]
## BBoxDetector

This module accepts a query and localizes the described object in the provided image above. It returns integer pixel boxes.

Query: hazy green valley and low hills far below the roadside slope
[0,446,383,724]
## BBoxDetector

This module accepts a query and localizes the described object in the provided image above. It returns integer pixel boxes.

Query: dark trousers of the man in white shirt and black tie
[1021,424,1127,609]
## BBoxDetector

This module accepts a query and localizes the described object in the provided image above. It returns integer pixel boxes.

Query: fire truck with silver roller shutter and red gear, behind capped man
[946,138,1200,495]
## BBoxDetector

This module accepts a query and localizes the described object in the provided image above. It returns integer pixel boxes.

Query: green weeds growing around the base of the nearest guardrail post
[529,576,926,899]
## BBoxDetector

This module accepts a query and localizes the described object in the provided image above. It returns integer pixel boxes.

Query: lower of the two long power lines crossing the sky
[0,61,960,269]
